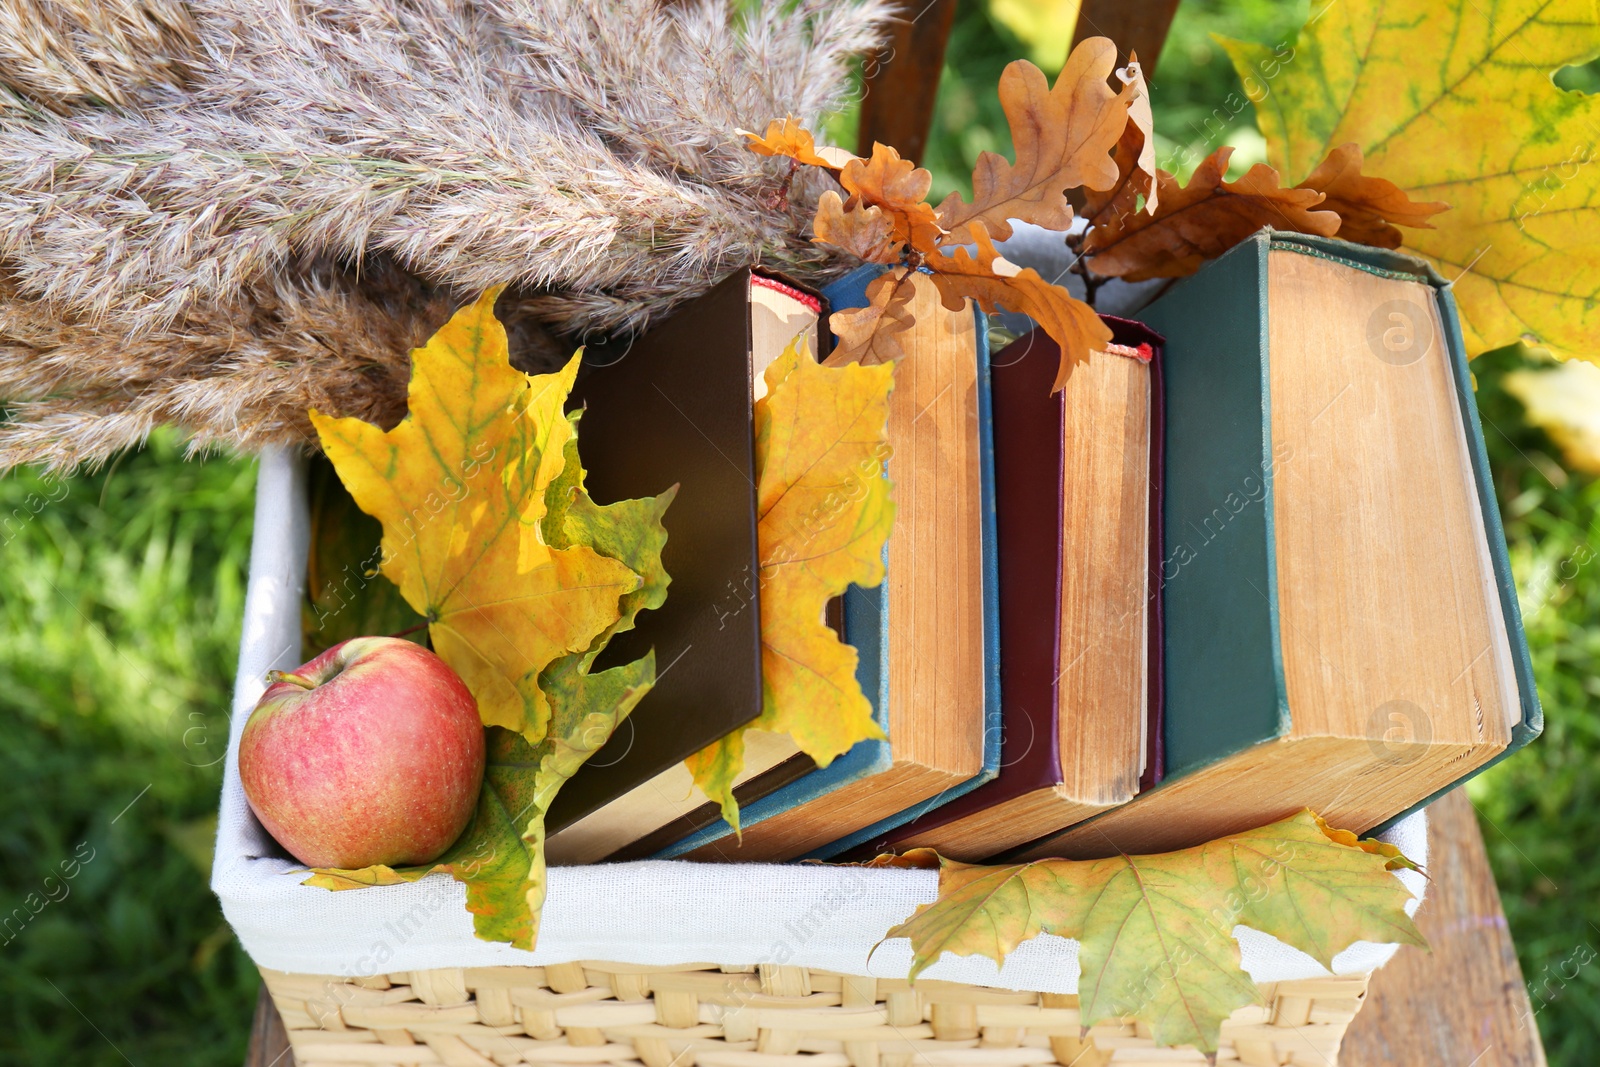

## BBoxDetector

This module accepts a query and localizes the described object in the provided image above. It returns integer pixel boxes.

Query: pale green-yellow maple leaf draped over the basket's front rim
[885,811,1427,1051]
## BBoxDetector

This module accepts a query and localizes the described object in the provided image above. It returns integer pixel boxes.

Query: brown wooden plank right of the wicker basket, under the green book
[1339,789,1544,1067]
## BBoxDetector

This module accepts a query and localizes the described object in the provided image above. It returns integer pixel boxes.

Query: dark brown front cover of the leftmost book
[546,270,774,833]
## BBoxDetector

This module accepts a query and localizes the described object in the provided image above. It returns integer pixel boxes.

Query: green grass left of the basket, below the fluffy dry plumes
[0,437,259,1067]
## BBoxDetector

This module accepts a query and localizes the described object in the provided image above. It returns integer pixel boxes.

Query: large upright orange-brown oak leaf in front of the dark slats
[938,37,1149,242]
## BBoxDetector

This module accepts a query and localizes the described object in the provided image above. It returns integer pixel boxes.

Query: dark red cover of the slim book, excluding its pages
[851,317,1163,859]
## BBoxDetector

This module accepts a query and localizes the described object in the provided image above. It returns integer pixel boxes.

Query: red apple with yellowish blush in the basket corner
[238,637,483,869]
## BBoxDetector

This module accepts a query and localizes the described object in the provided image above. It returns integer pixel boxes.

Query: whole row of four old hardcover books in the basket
[534,230,1542,864]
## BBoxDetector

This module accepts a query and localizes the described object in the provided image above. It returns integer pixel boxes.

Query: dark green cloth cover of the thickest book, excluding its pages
[1142,230,1544,825]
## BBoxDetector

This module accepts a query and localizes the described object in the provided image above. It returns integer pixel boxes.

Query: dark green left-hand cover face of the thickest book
[1142,237,1290,781]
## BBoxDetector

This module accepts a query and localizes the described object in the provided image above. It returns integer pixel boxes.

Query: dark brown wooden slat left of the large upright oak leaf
[856,0,955,162]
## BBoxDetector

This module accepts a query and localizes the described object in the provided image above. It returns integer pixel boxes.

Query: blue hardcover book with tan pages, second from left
[666,265,986,862]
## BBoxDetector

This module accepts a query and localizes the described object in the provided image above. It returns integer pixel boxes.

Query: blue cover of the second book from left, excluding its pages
[658,264,1000,859]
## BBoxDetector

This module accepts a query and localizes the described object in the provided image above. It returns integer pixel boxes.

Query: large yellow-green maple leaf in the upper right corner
[1224,0,1600,360]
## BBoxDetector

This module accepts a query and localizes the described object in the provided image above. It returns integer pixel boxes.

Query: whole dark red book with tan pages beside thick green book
[850,317,1163,861]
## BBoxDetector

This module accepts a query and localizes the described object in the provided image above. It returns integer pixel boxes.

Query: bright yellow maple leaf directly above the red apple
[312,290,640,744]
